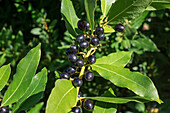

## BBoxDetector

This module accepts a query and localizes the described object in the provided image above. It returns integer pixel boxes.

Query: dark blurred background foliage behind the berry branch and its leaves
[0,0,170,113]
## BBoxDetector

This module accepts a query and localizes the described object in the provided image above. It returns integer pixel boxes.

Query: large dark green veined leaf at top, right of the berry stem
[106,0,152,24]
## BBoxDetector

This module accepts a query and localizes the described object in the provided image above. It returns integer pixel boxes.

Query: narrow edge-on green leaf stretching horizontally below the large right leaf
[86,97,149,104]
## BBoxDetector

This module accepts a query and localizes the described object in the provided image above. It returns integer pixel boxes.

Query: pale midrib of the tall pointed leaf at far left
[2,52,36,106]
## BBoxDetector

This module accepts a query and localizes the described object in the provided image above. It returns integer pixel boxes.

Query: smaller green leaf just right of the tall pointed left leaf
[13,68,47,112]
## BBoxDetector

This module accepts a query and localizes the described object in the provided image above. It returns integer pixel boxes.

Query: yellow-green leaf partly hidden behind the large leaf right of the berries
[95,51,132,67]
